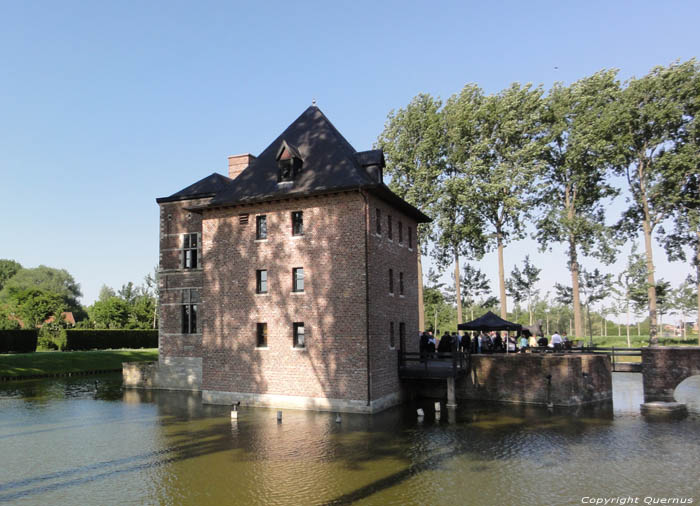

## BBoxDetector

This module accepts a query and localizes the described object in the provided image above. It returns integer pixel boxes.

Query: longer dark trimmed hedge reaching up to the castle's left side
[65,329,158,351]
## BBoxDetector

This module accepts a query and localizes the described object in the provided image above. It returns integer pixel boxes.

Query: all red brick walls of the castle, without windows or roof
[160,191,418,410]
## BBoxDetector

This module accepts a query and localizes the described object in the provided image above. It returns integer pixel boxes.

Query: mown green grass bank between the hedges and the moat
[0,348,158,378]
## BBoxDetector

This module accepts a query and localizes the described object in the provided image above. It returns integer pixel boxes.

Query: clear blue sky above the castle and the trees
[0,0,700,314]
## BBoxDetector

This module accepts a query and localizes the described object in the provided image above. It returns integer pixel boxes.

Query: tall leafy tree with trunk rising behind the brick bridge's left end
[609,60,697,346]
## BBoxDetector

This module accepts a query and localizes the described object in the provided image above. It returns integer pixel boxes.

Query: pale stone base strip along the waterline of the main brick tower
[202,390,403,414]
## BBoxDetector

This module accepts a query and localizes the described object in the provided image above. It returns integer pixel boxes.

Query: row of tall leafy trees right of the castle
[377,59,700,344]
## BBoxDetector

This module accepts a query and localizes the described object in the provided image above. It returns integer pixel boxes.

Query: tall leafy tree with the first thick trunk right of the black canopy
[536,70,620,338]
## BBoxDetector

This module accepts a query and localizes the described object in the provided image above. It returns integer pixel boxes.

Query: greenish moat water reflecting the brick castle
[0,373,700,506]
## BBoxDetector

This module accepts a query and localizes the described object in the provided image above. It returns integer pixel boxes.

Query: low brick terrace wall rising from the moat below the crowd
[406,353,612,406]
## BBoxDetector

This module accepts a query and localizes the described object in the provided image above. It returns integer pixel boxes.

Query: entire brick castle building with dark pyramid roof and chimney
[157,106,429,413]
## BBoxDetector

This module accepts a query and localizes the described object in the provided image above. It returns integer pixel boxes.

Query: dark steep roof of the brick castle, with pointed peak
[156,106,431,223]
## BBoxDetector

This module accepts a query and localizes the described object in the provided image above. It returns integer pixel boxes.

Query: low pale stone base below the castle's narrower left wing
[122,357,202,391]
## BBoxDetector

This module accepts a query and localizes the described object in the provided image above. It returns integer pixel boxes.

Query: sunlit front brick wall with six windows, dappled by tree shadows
[201,192,367,400]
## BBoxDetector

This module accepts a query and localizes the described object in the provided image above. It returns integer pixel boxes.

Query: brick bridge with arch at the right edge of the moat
[642,346,700,402]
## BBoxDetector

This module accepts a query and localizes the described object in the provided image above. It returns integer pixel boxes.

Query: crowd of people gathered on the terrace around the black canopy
[419,331,572,357]
